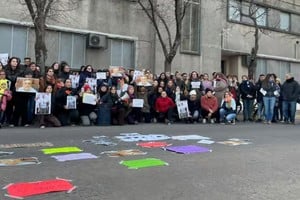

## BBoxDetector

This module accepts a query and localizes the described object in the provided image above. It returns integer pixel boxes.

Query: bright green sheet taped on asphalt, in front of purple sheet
[120,158,168,169]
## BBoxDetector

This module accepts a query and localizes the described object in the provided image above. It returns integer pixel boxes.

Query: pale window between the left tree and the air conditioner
[58,33,86,69]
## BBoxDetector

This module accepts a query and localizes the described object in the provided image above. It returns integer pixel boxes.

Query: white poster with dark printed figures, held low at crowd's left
[35,92,51,115]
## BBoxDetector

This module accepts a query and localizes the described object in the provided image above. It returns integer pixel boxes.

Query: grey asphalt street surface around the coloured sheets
[0,123,300,200]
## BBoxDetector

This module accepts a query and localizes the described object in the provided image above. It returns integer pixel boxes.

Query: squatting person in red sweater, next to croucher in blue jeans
[201,88,218,124]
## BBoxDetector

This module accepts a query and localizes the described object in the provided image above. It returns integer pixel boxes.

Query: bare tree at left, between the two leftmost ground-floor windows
[19,0,80,70]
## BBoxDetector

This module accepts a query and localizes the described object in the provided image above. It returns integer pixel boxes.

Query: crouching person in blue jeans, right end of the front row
[220,92,236,124]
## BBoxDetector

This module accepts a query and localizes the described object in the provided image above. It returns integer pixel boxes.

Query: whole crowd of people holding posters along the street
[0,57,300,128]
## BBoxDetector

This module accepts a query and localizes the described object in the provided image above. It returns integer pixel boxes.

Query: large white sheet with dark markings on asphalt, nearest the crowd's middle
[115,133,170,142]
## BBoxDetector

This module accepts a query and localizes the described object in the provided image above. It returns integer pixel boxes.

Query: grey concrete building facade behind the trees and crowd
[0,0,300,80]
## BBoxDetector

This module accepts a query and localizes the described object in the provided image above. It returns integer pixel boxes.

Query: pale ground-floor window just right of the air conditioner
[110,40,134,68]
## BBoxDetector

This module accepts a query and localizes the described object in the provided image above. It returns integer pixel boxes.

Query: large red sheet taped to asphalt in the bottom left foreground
[3,179,76,199]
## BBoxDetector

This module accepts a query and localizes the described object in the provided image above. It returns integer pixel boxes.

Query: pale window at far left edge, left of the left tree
[0,24,28,60]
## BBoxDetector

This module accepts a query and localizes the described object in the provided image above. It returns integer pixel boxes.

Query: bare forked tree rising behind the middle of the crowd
[137,0,189,71]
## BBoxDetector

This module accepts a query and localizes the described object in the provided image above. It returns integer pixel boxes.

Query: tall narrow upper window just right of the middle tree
[181,0,200,53]
